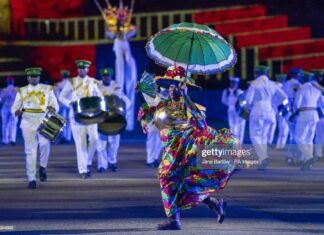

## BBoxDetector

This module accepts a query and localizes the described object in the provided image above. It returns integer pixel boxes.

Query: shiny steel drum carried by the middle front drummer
[72,96,106,124]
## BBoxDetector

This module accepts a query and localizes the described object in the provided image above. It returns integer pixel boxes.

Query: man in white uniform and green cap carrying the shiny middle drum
[59,60,101,179]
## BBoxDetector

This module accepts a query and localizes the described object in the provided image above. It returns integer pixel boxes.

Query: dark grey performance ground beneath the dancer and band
[0,144,324,235]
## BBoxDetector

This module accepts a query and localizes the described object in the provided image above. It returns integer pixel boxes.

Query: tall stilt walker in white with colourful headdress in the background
[104,1,137,130]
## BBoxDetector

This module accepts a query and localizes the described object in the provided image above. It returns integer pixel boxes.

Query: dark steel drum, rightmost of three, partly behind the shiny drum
[98,95,127,135]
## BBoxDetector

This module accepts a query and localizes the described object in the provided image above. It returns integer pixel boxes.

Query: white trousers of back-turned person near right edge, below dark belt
[295,110,318,161]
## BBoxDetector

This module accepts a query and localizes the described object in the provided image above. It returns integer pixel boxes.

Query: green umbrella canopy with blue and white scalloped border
[146,23,237,74]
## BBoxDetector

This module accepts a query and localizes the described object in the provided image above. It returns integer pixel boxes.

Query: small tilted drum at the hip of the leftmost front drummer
[38,112,66,142]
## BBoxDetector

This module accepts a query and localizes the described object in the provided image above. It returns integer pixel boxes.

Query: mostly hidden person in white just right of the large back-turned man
[274,74,289,149]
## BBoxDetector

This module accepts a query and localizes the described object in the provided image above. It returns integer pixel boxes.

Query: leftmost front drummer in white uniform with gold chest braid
[11,67,59,189]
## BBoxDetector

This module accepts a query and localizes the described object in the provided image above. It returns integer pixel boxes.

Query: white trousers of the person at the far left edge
[1,105,18,144]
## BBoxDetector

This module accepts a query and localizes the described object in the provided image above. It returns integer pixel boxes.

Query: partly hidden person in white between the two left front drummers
[54,70,72,143]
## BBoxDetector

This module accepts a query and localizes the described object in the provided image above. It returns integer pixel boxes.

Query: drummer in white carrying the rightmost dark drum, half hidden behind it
[88,68,130,173]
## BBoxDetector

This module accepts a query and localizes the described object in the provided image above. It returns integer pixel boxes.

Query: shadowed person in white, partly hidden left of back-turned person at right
[282,68,302,165]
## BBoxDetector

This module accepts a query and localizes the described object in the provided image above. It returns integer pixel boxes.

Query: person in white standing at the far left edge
[0,77,18,145]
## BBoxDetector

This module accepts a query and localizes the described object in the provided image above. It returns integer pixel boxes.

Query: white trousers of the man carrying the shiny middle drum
[70,118,98,174]
